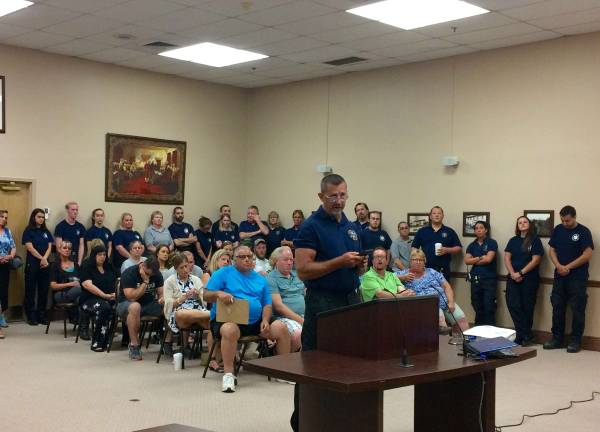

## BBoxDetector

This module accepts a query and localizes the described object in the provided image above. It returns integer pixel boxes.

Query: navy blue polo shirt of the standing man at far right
[548,224,594,279]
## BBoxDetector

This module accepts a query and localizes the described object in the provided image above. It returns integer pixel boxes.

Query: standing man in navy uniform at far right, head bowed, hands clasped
[544,206,594,353]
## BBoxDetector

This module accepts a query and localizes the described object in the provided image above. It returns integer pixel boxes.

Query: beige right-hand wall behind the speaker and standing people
[246,34,600,336]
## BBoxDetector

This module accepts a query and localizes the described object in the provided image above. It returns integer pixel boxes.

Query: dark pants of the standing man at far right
[550,277,587,342]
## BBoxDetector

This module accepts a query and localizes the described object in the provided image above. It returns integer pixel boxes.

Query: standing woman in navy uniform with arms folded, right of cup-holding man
[465,221,498,326]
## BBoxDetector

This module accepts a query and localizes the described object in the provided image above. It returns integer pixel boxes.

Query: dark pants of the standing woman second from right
[506,275,540,342]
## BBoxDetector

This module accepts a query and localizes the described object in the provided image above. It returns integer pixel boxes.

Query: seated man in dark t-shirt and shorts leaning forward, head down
[117,255,163,360]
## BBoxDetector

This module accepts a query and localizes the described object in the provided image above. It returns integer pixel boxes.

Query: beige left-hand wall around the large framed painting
[0,45,246,232]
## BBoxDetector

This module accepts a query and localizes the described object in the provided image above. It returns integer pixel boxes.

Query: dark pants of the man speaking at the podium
[290,290,360,432]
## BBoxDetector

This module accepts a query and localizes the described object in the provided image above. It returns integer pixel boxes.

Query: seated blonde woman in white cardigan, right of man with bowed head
[163,253,212,352]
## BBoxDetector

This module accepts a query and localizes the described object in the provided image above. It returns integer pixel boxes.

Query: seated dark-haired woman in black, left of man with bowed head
[79,246,116,352]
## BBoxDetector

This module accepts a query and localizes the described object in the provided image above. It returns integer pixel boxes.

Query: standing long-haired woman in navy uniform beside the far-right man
[504,216,544,346]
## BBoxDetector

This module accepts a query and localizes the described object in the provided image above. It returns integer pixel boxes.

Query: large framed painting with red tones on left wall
[104,133,186,204]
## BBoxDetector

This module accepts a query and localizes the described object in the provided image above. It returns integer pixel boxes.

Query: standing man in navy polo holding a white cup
[412,206,462,281]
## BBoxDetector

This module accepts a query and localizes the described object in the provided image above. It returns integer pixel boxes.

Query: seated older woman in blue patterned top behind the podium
[396,249,469,331]
